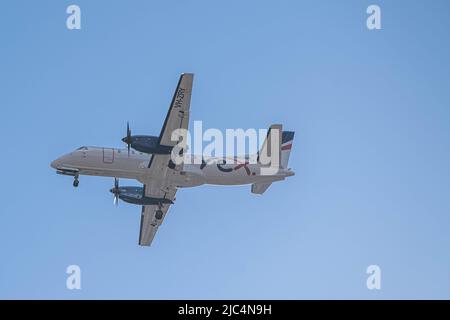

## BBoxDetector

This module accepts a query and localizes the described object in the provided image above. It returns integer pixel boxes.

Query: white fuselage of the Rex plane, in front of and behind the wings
[51,147,294,187]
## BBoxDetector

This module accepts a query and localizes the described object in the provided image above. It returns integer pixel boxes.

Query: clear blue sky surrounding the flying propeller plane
[0,0,450,299]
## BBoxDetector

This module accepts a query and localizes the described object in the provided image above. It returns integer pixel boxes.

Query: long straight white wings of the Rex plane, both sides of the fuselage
[139,73,194,246]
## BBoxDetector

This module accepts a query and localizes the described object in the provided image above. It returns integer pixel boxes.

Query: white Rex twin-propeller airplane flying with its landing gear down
[50,73,294,246]
